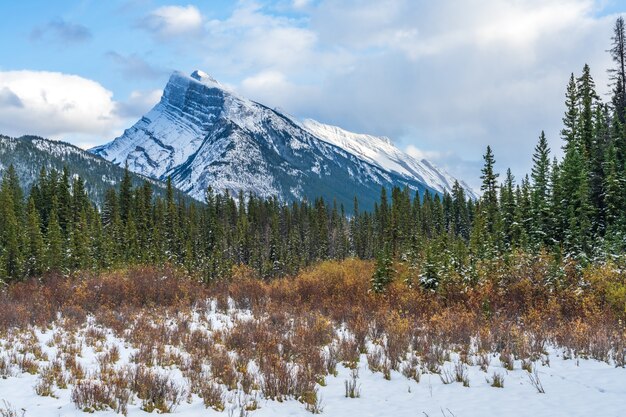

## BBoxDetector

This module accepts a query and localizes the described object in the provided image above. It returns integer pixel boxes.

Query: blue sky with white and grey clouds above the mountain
[0,0,626,188]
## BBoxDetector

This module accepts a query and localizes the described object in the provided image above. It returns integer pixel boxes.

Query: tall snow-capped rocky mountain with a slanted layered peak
[91,71,473,208]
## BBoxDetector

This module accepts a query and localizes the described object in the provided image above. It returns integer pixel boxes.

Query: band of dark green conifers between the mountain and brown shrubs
[0,18,626,291]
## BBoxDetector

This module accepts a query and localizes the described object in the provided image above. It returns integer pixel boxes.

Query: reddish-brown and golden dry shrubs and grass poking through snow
[0,258,626,413]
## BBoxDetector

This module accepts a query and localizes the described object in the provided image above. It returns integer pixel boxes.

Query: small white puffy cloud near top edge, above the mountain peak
[140,5,203,37]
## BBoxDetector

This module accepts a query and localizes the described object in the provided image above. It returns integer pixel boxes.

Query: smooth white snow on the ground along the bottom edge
[0,302,626,417]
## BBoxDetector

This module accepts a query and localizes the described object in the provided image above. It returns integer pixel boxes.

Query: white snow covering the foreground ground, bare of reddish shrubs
[0,305,626,417]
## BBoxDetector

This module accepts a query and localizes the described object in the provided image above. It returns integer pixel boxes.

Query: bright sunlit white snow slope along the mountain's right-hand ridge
[302,119,477,198]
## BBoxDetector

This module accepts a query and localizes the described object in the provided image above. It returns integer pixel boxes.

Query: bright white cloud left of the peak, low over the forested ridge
[0,71,162,146]
